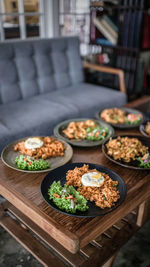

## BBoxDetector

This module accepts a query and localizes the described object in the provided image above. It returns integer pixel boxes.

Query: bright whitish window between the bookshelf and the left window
[59,0,90,55]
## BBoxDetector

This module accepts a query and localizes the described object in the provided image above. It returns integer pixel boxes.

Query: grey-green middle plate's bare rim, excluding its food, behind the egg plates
[54,118,115,147]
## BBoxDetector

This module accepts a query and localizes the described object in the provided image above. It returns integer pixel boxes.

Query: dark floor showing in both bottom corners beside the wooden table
[0,215,150,267]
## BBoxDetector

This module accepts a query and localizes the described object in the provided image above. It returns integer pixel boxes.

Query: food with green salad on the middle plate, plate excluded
[63,120,109,141]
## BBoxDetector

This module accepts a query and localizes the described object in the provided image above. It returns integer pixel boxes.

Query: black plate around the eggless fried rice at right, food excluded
[102,135,150,170]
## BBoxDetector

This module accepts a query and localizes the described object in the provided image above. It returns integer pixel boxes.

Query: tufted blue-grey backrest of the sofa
[0,37,83,104]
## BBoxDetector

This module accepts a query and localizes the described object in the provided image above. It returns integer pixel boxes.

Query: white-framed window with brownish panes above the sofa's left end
[0,0,45,41]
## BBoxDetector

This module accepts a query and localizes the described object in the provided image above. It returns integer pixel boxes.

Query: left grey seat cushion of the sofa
[0,96,79,151]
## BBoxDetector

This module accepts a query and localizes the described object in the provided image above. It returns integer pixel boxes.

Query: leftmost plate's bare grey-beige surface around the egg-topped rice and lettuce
[1,137,73,173]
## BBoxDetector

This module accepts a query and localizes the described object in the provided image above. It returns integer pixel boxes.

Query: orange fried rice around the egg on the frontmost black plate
[66,164,120,209]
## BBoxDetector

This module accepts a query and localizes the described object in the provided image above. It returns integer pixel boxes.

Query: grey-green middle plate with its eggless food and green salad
[54,118,114,147]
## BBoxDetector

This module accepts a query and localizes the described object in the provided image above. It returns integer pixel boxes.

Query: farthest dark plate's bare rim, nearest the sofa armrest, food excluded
[95,107,146,129]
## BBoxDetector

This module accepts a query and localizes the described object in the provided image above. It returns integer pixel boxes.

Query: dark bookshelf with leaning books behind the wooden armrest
[90,0,150,99]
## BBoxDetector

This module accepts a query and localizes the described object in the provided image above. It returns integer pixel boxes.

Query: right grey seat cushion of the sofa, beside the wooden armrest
[42,83,127,117]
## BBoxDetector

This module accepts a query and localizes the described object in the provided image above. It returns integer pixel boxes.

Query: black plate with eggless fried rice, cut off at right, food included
[102,135,150,170]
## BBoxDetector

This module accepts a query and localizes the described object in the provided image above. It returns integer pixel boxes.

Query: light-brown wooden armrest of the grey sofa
[83,61,126,94]
